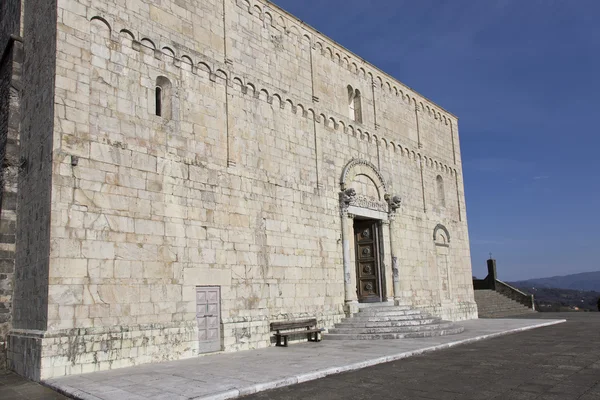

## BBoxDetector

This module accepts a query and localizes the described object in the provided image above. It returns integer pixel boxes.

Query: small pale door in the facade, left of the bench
[196,286,221,353]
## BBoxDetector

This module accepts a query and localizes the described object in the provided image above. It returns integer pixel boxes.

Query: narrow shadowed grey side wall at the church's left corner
[8,0,56,379]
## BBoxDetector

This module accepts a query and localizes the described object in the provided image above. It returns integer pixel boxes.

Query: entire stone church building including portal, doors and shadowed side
[0,0,477,379]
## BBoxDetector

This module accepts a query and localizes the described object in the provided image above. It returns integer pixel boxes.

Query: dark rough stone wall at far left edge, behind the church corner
[0,1,23,369]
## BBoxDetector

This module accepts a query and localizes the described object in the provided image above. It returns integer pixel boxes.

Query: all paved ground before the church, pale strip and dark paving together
[0,313,600,400]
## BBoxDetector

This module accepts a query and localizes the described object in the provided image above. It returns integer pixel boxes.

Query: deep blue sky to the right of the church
[274,0,600,281]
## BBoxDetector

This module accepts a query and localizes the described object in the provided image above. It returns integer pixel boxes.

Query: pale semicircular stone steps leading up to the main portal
[323,303,464,340]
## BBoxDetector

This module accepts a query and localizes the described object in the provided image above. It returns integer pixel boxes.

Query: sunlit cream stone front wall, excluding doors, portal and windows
[9,0,476,378]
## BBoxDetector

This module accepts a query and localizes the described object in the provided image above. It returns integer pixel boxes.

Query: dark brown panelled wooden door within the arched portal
[354,219,385,303]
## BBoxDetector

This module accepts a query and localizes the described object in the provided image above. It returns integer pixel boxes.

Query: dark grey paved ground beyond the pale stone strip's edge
[244,313,600,400]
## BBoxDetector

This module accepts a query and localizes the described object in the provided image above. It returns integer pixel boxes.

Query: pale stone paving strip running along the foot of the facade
[44,319,566,400]
